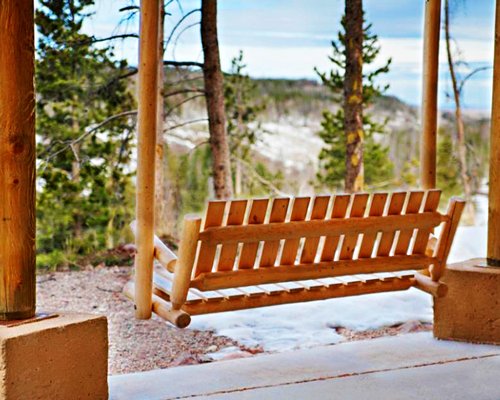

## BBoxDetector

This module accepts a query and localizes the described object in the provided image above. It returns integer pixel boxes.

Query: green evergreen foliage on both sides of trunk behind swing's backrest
[315,13,393,189]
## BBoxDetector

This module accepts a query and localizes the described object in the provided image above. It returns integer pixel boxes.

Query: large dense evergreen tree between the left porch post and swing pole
[36,0,135,266]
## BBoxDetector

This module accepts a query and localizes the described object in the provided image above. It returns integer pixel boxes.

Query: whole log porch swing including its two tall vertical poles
[124,0,464,327]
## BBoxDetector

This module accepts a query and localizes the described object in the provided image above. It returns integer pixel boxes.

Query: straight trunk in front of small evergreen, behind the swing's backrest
[344,0,364,192]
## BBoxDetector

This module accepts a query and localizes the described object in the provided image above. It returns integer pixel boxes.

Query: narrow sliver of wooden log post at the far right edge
[487,0,500,267]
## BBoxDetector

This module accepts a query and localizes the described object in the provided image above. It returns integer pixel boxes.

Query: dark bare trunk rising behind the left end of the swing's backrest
[201,0,233,199]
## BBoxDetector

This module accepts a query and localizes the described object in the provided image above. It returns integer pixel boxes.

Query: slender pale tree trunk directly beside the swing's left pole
[155,0,178,237]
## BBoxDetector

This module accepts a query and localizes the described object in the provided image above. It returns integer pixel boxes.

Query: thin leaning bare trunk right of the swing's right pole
[444,0,474,219]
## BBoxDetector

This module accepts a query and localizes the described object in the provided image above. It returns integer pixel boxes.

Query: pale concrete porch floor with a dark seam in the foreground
[109,332,500,400]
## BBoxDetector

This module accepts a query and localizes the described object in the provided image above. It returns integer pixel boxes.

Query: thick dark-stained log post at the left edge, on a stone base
[0,0,35,320]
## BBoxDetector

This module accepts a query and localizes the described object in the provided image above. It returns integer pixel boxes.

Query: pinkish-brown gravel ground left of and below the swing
[37,267,432,375]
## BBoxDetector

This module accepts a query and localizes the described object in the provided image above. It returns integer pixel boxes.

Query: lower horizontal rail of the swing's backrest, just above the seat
[191,255,436,291]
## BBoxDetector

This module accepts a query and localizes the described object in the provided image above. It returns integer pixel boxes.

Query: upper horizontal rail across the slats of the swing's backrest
[198,212,447,244]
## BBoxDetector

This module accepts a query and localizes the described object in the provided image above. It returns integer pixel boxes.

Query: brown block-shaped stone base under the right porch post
[434,259,500,344]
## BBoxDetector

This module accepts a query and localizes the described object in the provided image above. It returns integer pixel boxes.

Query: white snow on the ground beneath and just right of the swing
[191,219,487,351]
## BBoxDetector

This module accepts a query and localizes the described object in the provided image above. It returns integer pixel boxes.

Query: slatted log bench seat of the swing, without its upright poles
[124,190,465,328]
